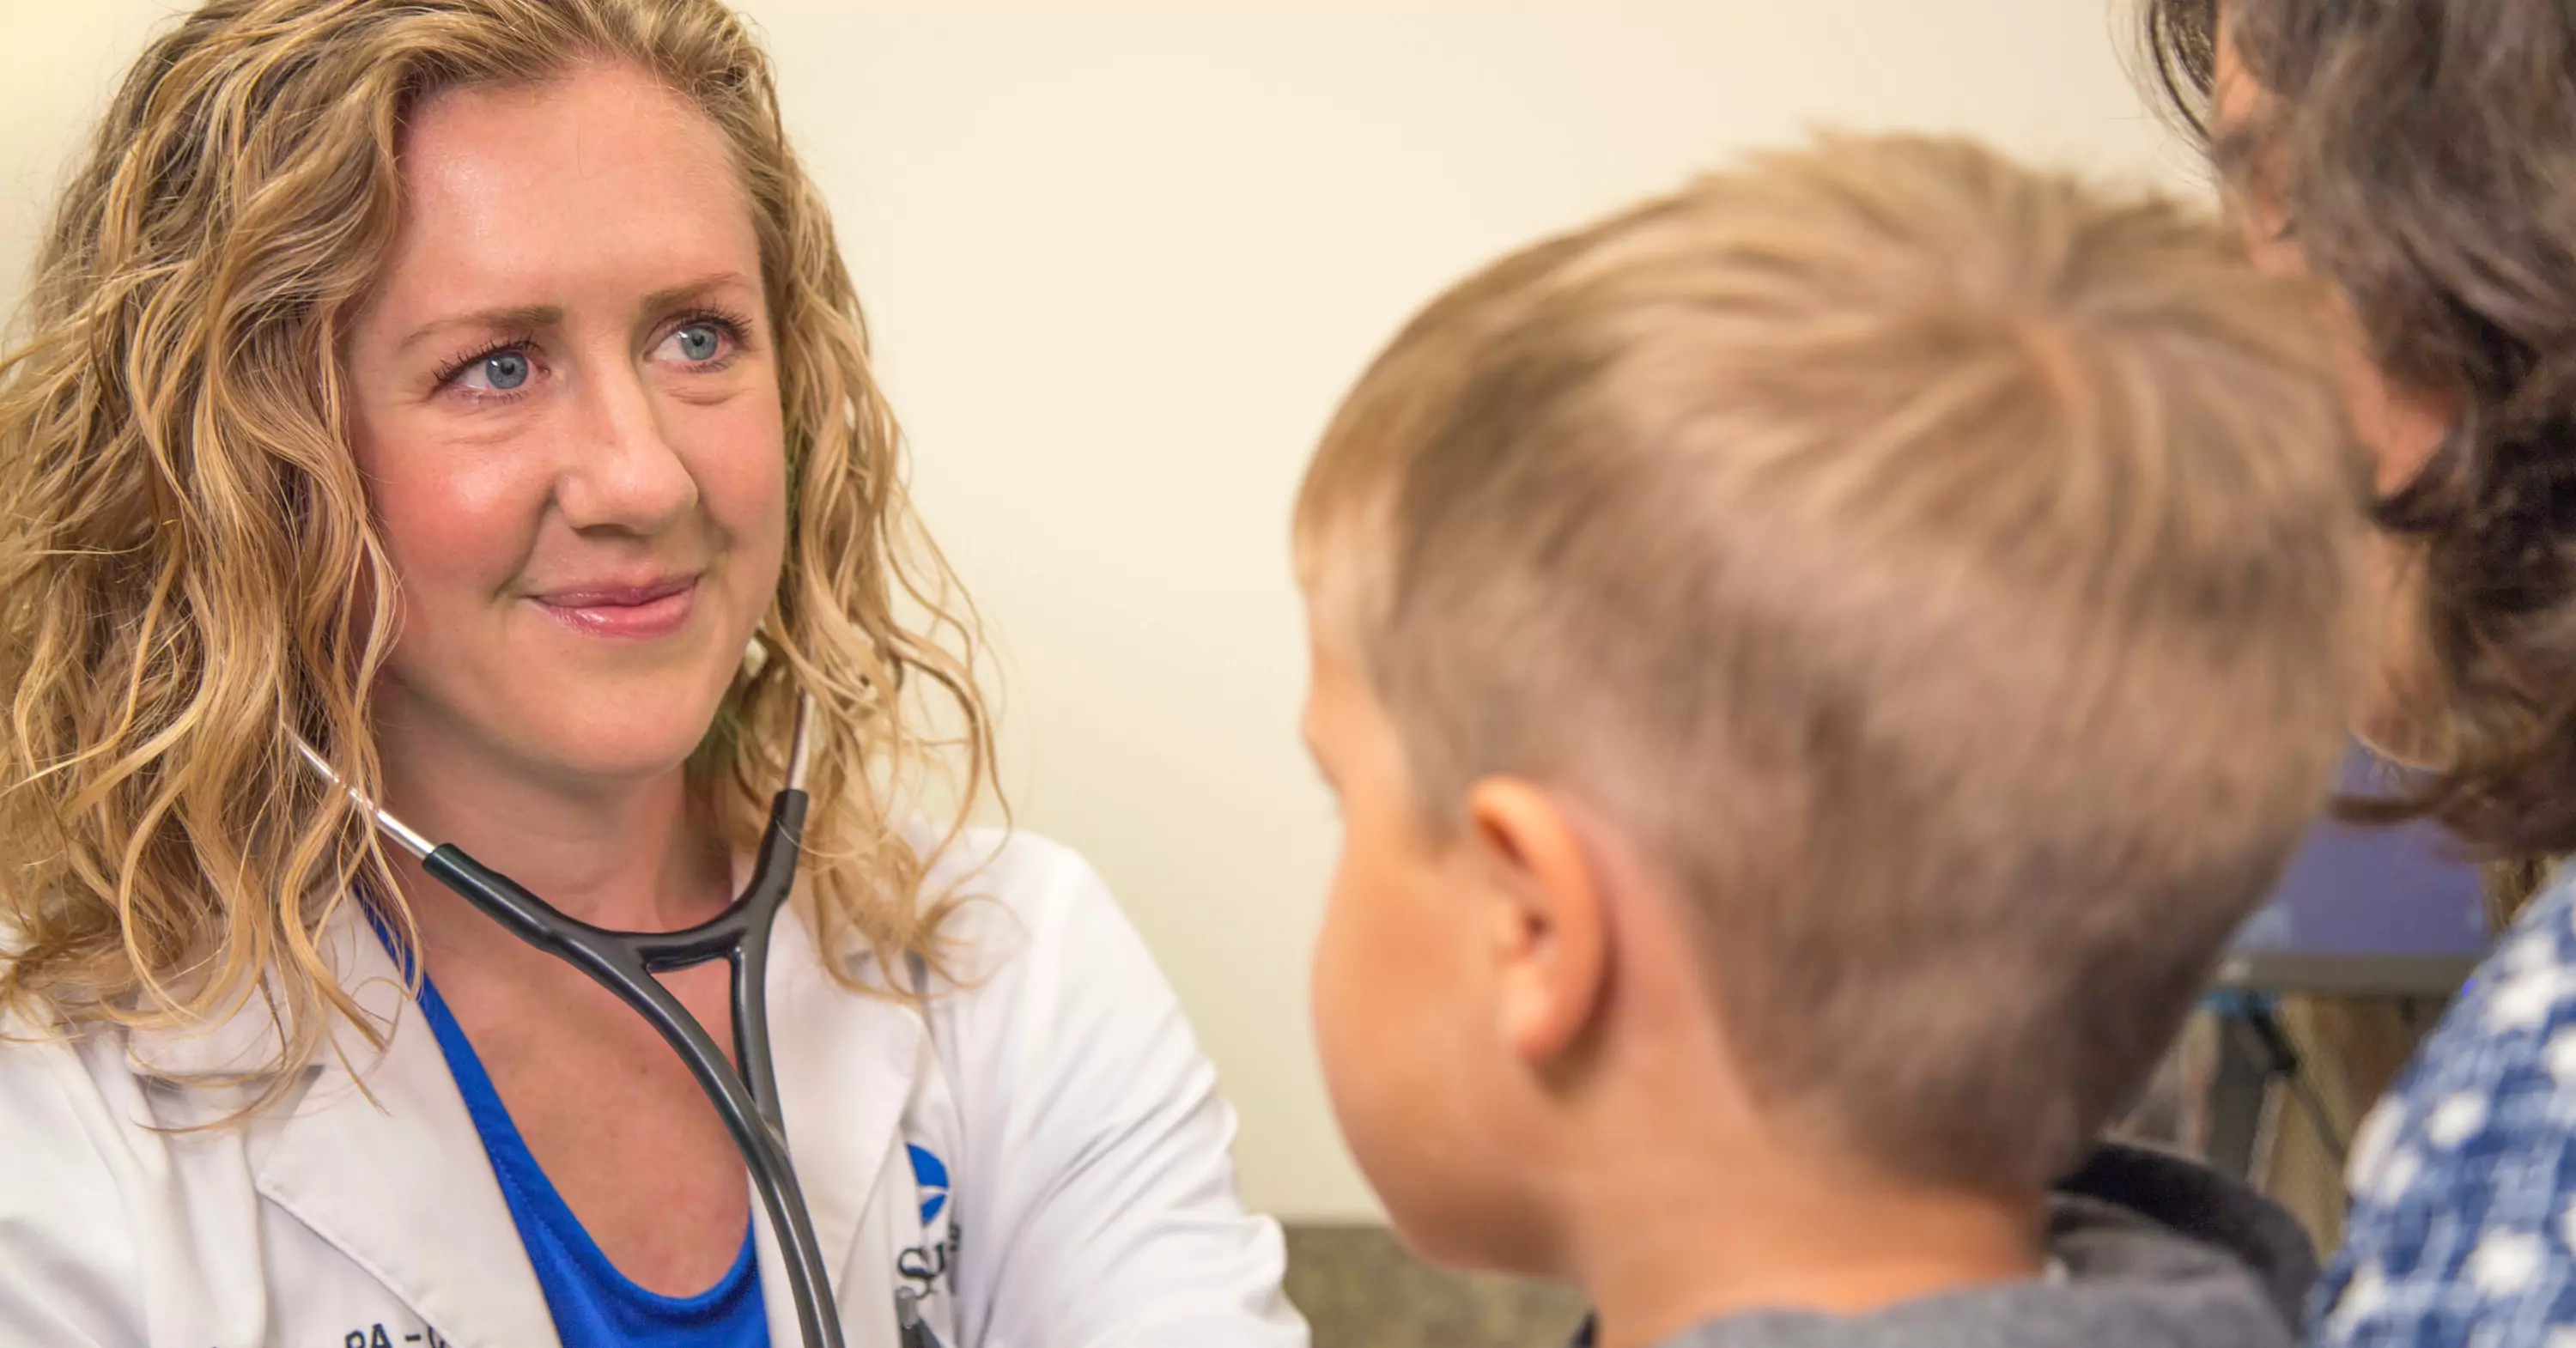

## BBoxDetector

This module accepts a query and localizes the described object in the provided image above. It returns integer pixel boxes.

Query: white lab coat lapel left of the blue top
[250,920,556,1348]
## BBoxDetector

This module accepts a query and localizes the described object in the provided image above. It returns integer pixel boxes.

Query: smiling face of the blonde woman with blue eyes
[345,64,786,781]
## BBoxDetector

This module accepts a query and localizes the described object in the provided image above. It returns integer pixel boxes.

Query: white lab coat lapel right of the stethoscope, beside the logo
[755,908,927,1348]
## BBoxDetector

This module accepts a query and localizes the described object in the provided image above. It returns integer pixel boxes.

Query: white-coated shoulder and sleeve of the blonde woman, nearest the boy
[925,833,1306,1348]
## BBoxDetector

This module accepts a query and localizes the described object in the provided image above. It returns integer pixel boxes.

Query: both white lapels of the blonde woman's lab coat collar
[126,891,927,1348]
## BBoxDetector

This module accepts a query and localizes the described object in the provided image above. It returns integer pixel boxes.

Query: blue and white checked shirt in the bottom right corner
[2311,874,2576,1348]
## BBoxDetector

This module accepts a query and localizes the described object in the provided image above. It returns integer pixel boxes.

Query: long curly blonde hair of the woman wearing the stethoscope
[0,0,992,1067]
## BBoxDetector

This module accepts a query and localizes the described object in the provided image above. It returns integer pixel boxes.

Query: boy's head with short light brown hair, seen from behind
[1296,139,2365,1266]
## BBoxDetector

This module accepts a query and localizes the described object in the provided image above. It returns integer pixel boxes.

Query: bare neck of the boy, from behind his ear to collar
[1543,860,2048,1348]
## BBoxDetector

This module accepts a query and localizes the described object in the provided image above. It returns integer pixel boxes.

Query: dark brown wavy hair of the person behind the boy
[2141,0,2576,922]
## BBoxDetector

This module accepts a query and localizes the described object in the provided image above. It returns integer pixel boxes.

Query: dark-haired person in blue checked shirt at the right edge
[2146,0,2576,1345]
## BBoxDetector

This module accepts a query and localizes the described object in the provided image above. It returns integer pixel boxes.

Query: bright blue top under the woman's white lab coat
[420,980,770,1348]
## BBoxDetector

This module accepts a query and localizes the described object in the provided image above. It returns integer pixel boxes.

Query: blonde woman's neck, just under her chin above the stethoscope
[363,701,732,954]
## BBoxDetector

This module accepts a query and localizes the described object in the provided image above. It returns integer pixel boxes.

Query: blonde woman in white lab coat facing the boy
[0,0,1303,1348]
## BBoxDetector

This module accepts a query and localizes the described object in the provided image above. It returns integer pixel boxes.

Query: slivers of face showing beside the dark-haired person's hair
[2213,5,2460,763]
